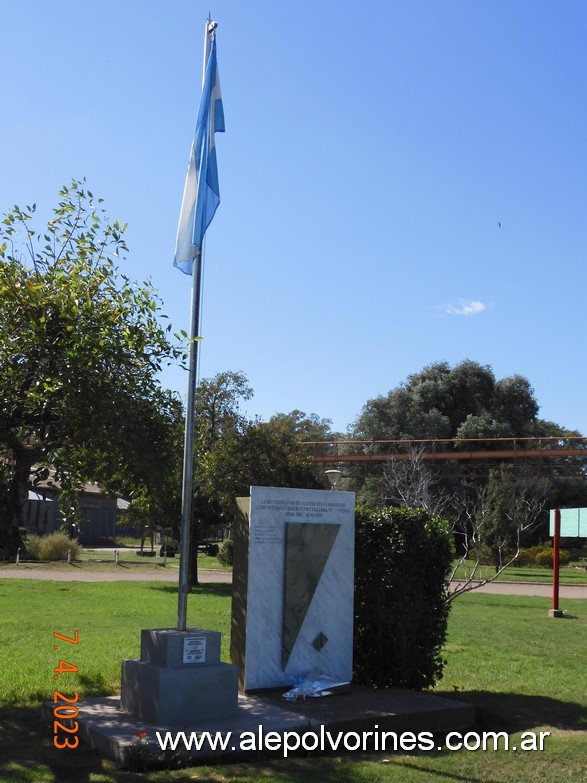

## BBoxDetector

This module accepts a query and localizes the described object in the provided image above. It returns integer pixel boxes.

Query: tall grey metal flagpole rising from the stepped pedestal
[177,16,215,631]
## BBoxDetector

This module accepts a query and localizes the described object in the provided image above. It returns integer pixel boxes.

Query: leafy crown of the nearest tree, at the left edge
[0,181,182,555]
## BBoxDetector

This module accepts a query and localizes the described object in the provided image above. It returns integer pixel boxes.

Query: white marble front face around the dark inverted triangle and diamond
[244,487,355,690]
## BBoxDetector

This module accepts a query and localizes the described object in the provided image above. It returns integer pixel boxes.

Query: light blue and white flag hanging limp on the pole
[173,37,224,275]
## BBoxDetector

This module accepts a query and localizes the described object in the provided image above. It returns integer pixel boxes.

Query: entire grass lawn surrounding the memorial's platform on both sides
[0,580,587,783]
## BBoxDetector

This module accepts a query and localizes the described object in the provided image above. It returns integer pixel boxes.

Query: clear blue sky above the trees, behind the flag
[0,0,587,433]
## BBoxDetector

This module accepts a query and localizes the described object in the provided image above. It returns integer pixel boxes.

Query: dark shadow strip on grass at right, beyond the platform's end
[438,691,587,734]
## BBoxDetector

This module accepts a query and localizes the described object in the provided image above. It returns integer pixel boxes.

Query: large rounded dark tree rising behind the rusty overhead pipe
[353,359,584,502]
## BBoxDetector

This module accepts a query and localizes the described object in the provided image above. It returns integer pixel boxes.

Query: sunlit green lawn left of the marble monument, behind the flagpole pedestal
[0,579,231,705]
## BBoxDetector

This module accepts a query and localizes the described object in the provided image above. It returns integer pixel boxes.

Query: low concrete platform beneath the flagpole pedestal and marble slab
[57,685,475,769]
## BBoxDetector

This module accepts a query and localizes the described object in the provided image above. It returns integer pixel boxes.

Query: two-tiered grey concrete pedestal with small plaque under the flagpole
[120,628,238,725]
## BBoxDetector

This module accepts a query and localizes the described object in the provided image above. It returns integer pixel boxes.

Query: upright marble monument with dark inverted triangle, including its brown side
[231,487,355,691]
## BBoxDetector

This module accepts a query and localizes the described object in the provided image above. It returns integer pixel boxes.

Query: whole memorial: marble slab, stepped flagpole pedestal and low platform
[70,487,474,764]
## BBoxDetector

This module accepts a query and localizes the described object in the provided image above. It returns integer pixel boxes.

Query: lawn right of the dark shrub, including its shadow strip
[436,593,587,730]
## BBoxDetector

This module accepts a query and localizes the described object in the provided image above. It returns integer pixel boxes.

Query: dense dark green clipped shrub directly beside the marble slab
[353,508,451,689]
